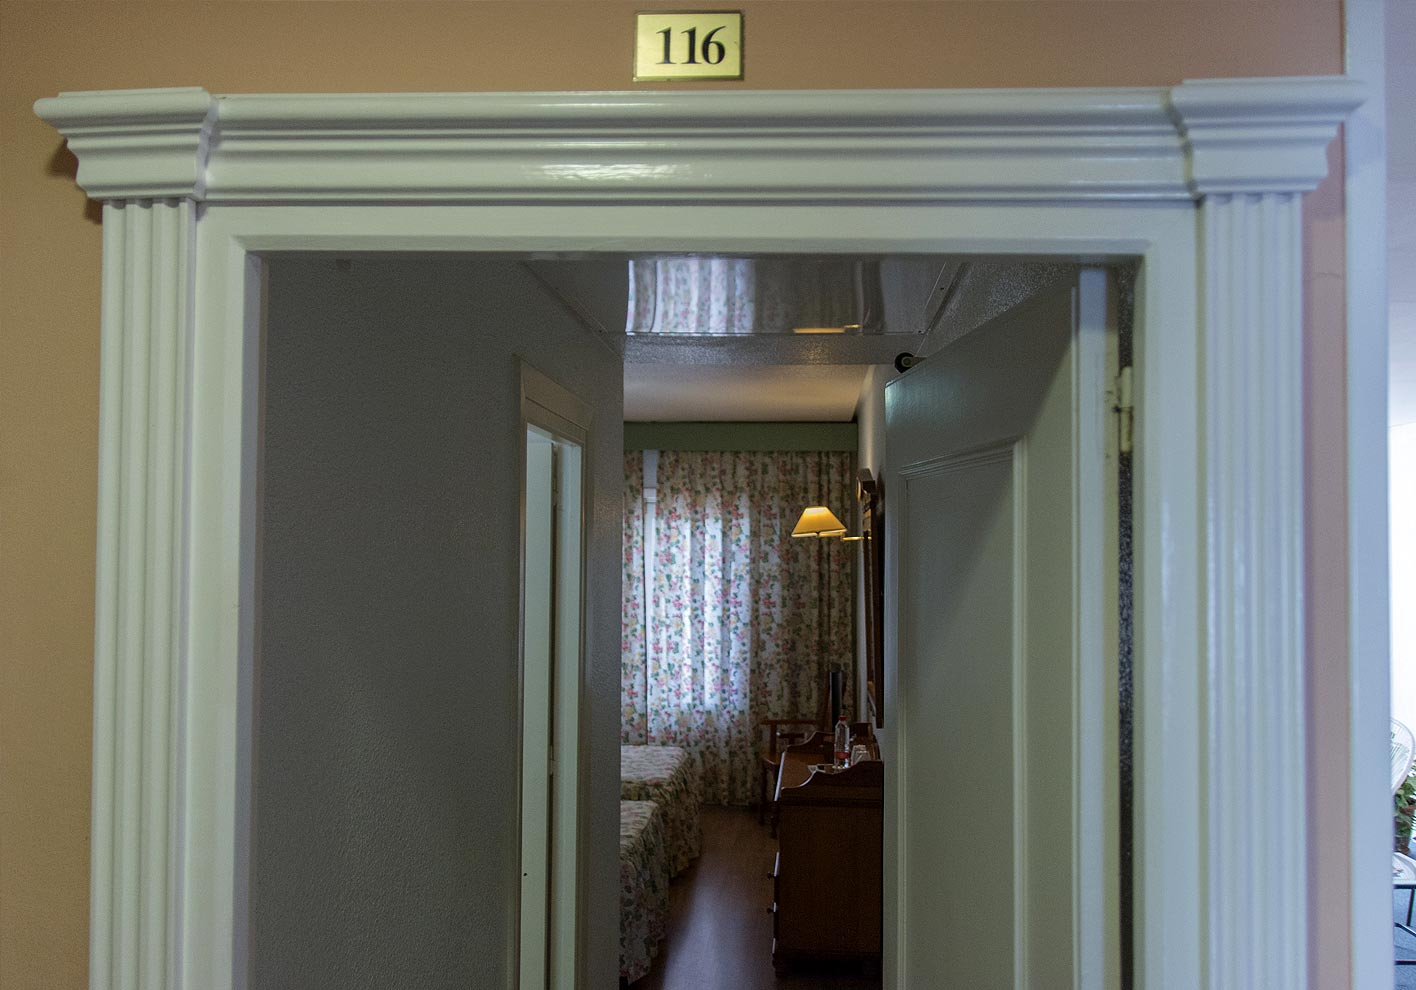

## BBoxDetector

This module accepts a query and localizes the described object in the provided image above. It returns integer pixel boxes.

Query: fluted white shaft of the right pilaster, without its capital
[1199,193,1308,987]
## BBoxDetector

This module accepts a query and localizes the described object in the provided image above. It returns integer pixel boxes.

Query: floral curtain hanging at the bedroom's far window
[620,450,857,804]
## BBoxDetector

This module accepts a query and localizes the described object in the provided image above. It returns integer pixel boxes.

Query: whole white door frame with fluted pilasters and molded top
[37,76,1362,990]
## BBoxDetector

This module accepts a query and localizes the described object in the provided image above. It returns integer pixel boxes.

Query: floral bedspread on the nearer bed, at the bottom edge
[620,800,668,983]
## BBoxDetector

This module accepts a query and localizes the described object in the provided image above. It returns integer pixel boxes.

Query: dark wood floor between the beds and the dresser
[632,806,881,990]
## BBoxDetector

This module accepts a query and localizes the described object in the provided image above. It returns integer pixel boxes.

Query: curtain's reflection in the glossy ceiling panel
[626,256,860,334]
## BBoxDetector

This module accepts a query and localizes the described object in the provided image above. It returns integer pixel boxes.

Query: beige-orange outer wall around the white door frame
[0,0,1345,990]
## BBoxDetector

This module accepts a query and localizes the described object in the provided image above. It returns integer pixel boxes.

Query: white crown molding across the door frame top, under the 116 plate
[35,76,1362,204]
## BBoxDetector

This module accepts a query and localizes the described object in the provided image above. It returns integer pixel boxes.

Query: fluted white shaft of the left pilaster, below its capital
[89,200,195,990]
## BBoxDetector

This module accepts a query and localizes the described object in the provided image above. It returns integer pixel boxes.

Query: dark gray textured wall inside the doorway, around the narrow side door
[251,256,623,990]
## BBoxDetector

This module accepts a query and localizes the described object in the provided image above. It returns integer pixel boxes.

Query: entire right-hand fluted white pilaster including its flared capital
[1171,79,1361,990]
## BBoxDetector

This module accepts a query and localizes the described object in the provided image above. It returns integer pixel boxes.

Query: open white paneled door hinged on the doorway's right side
[885,271,1119,990]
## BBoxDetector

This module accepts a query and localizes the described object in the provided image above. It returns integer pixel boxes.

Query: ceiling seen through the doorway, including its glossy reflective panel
[524,255,961,422]
